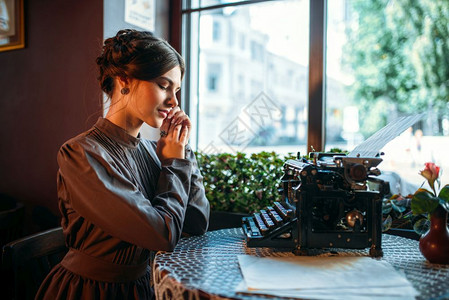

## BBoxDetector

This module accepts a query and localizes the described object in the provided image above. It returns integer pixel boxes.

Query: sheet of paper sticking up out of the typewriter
[348,113,425,157]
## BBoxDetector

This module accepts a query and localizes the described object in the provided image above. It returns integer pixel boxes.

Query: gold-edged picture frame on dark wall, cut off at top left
[0,0,25,52]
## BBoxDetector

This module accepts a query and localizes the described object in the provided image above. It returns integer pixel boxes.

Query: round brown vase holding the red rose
[419,205,449,264]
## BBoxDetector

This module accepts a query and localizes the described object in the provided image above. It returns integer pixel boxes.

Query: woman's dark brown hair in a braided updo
[96,29,185,97]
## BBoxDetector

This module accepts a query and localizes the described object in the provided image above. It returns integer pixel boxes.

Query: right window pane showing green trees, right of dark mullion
[326,0,449,191]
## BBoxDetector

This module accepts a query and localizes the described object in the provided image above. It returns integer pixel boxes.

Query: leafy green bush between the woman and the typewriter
[196,152,293,213]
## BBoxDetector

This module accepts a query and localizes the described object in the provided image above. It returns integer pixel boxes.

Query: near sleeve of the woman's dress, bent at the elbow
[58,141,192,250]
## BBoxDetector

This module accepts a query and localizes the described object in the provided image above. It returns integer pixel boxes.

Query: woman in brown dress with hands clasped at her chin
[36,30,209,299]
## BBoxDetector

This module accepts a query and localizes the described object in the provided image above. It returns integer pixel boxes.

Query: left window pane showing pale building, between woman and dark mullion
[184,0,309,154]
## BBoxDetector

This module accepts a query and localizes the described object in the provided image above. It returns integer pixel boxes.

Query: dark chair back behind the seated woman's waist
[2,227,68,300]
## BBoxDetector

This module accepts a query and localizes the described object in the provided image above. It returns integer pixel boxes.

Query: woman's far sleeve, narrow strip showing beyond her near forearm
[183,146,210,235]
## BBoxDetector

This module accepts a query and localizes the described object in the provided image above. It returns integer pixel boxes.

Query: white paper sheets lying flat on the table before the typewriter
[238,255,418,297]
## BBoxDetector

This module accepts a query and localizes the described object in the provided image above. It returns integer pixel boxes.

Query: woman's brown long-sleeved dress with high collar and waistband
[36,118,209,300]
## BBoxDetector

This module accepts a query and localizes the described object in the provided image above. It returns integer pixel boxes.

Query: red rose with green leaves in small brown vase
[411,162,449,264]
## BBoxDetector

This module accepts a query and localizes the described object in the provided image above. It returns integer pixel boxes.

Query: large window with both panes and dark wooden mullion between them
[179,0,449,185]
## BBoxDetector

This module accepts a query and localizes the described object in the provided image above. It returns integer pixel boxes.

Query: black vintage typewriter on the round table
[242,152,389,257]
